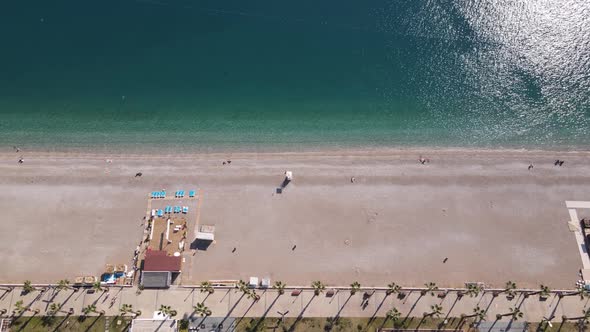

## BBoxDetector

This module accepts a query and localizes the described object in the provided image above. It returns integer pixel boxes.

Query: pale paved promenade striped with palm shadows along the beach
[0,287,588,322]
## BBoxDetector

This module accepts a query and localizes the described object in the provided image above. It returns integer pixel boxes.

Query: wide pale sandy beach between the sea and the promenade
[0,150,590,288]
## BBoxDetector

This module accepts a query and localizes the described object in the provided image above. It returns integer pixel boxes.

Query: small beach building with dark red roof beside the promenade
[141,249,181,288]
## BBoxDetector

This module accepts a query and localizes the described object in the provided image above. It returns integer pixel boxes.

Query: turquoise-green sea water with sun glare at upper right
[0,0,590,152]
